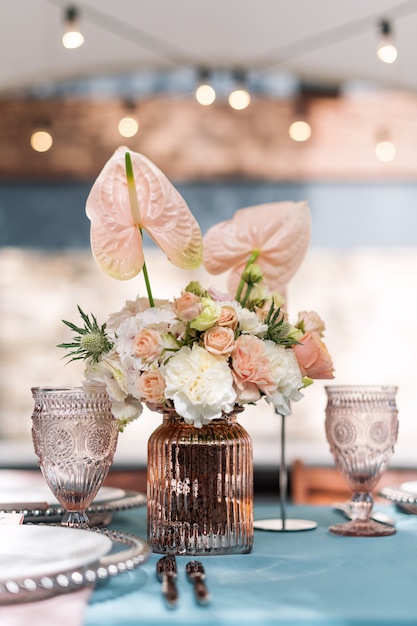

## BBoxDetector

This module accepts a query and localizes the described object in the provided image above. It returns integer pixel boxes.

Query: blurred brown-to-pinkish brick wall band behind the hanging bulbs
[0,93,417,181]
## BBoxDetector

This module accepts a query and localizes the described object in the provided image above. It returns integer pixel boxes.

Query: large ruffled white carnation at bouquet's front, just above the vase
[165,344,236,428]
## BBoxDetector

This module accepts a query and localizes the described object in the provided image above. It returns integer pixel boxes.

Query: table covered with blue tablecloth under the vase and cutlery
[84,504,417,626]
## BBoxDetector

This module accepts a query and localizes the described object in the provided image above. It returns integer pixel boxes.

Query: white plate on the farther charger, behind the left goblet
[0,470,126,509]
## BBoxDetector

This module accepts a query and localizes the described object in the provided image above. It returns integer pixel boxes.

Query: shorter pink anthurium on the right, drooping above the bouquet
[203,201,311,293]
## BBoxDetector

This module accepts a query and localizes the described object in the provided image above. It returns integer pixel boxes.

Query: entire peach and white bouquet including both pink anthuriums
[60,147,333,553]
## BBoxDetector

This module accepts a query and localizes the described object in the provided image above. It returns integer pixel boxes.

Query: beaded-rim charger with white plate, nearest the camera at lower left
[0,524,150,605]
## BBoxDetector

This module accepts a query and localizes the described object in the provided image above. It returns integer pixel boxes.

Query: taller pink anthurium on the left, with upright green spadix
[86,147,202,280]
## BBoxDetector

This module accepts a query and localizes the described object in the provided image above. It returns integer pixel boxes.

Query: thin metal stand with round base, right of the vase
[253,411,317,532]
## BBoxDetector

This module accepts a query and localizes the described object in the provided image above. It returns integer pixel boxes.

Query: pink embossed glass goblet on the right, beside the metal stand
[325,385,398,537]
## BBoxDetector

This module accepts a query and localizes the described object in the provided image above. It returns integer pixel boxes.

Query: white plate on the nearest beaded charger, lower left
[0,526,112,583]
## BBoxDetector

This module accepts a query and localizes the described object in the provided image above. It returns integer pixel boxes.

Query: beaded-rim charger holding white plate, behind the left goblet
[0,470,147,526]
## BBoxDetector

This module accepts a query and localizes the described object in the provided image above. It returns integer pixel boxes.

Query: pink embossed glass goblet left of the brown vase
[32,385,118,528]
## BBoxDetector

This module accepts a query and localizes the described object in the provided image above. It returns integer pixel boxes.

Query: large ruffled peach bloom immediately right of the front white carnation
[232,335,276,402]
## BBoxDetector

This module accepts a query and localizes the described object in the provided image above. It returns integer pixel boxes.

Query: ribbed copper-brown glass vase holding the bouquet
[148,408,253,555]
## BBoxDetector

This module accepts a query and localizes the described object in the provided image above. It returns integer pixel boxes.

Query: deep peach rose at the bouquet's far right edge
[293,332,334,378]
